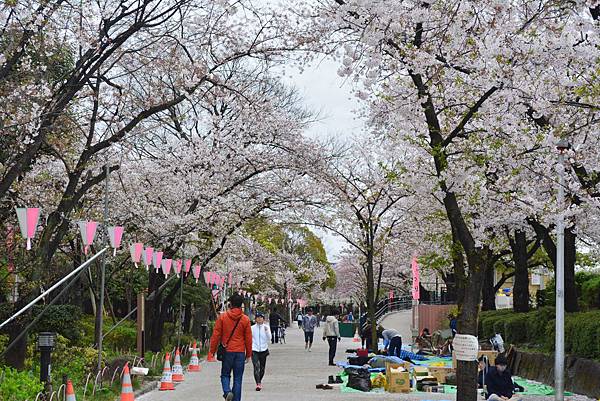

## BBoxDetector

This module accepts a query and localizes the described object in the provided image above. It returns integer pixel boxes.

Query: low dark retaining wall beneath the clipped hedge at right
[507,347,600,398]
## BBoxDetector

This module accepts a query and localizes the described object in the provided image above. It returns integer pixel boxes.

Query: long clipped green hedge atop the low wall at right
[479,307,600,359]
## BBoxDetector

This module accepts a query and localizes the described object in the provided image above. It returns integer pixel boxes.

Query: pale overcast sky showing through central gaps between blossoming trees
[284,59,364,262]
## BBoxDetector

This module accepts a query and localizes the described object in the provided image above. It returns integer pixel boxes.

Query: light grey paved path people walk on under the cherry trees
[137,324,455,401]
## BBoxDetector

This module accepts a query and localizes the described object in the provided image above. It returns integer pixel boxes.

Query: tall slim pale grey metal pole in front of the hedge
[554,139,569,401]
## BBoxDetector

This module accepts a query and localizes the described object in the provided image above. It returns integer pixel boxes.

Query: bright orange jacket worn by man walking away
[210,308,252,358]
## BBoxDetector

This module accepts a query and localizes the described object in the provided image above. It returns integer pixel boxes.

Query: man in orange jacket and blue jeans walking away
[210,294,252,401]
